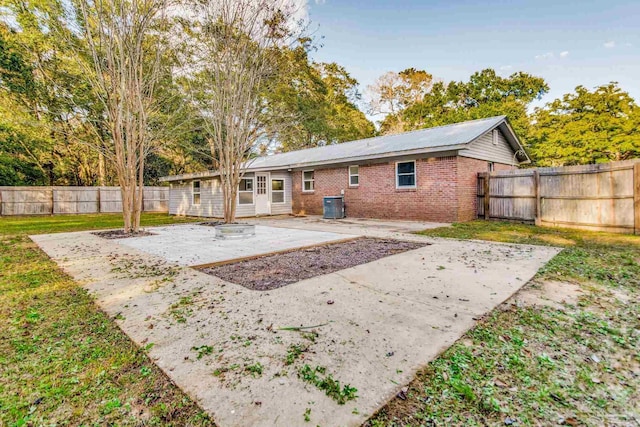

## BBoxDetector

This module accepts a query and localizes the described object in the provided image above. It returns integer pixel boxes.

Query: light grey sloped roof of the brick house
[161,116,522,181]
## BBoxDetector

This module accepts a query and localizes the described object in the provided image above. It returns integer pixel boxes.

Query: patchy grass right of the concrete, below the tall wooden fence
[367,221,640,426]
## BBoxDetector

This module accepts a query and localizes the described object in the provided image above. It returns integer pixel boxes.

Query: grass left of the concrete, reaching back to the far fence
[0,214,213,426]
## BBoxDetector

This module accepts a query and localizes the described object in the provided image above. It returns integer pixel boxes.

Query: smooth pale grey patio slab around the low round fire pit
[115,224,357,265]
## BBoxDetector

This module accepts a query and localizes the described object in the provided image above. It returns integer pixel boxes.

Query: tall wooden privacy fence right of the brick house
[478,159,640,234]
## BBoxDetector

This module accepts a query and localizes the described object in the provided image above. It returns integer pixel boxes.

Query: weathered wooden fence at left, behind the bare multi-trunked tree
[0,187,169,216]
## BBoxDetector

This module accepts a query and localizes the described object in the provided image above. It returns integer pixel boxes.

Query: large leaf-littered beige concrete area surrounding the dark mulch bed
[33,219,558,427]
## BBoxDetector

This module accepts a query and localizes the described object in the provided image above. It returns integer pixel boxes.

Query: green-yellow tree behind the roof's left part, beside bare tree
[265,43,375,151]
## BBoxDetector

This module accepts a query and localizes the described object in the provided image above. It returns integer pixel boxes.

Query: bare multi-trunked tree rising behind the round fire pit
[190,0,302,226]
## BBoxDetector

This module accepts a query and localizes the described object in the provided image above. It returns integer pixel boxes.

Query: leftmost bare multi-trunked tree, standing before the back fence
[70,0,175,233]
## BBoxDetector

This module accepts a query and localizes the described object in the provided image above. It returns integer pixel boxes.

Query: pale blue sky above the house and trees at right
[309,0,640,116]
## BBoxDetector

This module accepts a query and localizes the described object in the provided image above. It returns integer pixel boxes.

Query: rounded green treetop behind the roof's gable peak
[390,69,549,140]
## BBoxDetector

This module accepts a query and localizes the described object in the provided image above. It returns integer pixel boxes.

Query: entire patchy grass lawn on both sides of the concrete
[0,214,640,426]
